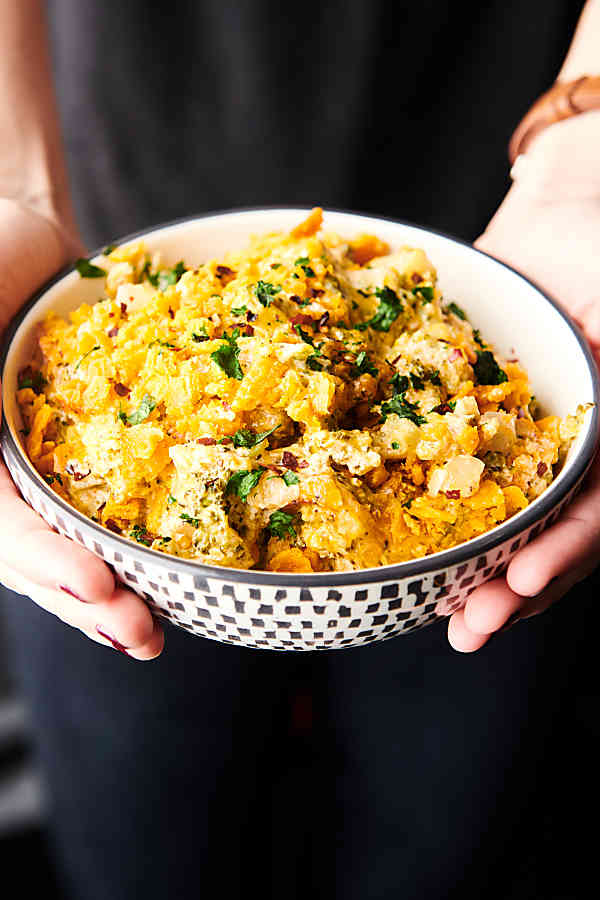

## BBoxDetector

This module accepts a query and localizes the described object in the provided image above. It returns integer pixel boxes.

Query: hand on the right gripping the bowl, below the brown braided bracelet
[448,113,600,653]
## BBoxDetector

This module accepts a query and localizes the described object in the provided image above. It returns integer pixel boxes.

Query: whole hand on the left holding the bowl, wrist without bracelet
[0,199,163,660]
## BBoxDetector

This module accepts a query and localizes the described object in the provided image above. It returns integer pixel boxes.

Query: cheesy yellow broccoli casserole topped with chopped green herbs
[18,209,581,572]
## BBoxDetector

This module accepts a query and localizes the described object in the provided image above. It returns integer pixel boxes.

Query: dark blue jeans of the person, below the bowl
[4,578,600,900]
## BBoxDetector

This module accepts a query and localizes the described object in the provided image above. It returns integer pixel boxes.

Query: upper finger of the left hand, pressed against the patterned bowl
[0,465,115,603]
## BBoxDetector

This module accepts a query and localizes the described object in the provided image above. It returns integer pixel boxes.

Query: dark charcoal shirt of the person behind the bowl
[48,0,582,247]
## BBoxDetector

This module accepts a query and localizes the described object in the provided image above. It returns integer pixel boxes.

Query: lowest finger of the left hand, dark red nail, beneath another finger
[0,564,164,660]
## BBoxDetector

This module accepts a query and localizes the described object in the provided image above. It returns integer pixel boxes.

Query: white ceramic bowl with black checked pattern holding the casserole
[1,209,599,650]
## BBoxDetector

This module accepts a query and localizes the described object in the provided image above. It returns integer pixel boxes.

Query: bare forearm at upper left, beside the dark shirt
[0,0,72,230]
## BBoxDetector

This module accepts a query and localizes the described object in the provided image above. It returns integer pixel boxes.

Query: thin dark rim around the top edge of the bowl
[0,204,600,589]
